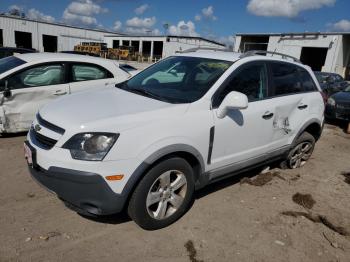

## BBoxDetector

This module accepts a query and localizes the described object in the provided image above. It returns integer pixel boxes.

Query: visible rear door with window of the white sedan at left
[69,63,117,93]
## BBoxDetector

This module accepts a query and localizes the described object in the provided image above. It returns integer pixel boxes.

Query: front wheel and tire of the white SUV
[128,157,194,230]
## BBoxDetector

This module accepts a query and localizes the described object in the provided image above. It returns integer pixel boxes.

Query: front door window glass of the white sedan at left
[7,64,65,89]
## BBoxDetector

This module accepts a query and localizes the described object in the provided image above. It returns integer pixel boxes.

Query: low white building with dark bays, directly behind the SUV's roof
[105,35,225,61]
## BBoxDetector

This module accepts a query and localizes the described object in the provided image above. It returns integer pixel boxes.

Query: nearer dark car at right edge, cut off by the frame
[325,86,350,122]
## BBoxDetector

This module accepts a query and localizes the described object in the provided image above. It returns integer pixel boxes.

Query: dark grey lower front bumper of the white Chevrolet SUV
[29,165,127,215]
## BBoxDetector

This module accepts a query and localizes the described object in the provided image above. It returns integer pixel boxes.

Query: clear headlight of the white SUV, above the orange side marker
[63,133,119,161]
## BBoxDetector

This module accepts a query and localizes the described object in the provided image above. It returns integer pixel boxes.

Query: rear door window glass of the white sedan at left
[72,64,113,82]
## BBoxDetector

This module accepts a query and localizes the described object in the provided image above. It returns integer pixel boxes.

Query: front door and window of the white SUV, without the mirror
[211,62,275,175]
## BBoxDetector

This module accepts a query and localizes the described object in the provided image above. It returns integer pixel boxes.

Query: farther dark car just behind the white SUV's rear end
[315,72,349,97]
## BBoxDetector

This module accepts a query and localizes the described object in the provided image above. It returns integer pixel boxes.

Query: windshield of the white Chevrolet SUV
[117,56,232,103]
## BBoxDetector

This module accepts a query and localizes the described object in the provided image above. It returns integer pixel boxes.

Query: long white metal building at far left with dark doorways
[0,15,120,52]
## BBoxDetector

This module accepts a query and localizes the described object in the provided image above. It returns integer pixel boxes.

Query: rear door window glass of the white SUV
[271,63,303,96]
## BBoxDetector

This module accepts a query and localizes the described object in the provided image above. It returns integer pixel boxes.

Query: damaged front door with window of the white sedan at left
[0,63,69,132]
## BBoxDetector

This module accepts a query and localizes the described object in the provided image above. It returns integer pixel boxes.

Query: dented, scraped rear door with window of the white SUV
[268,62,317,148]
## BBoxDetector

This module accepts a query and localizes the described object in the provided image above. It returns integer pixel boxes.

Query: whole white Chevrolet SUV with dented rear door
[25,50,324,229]
